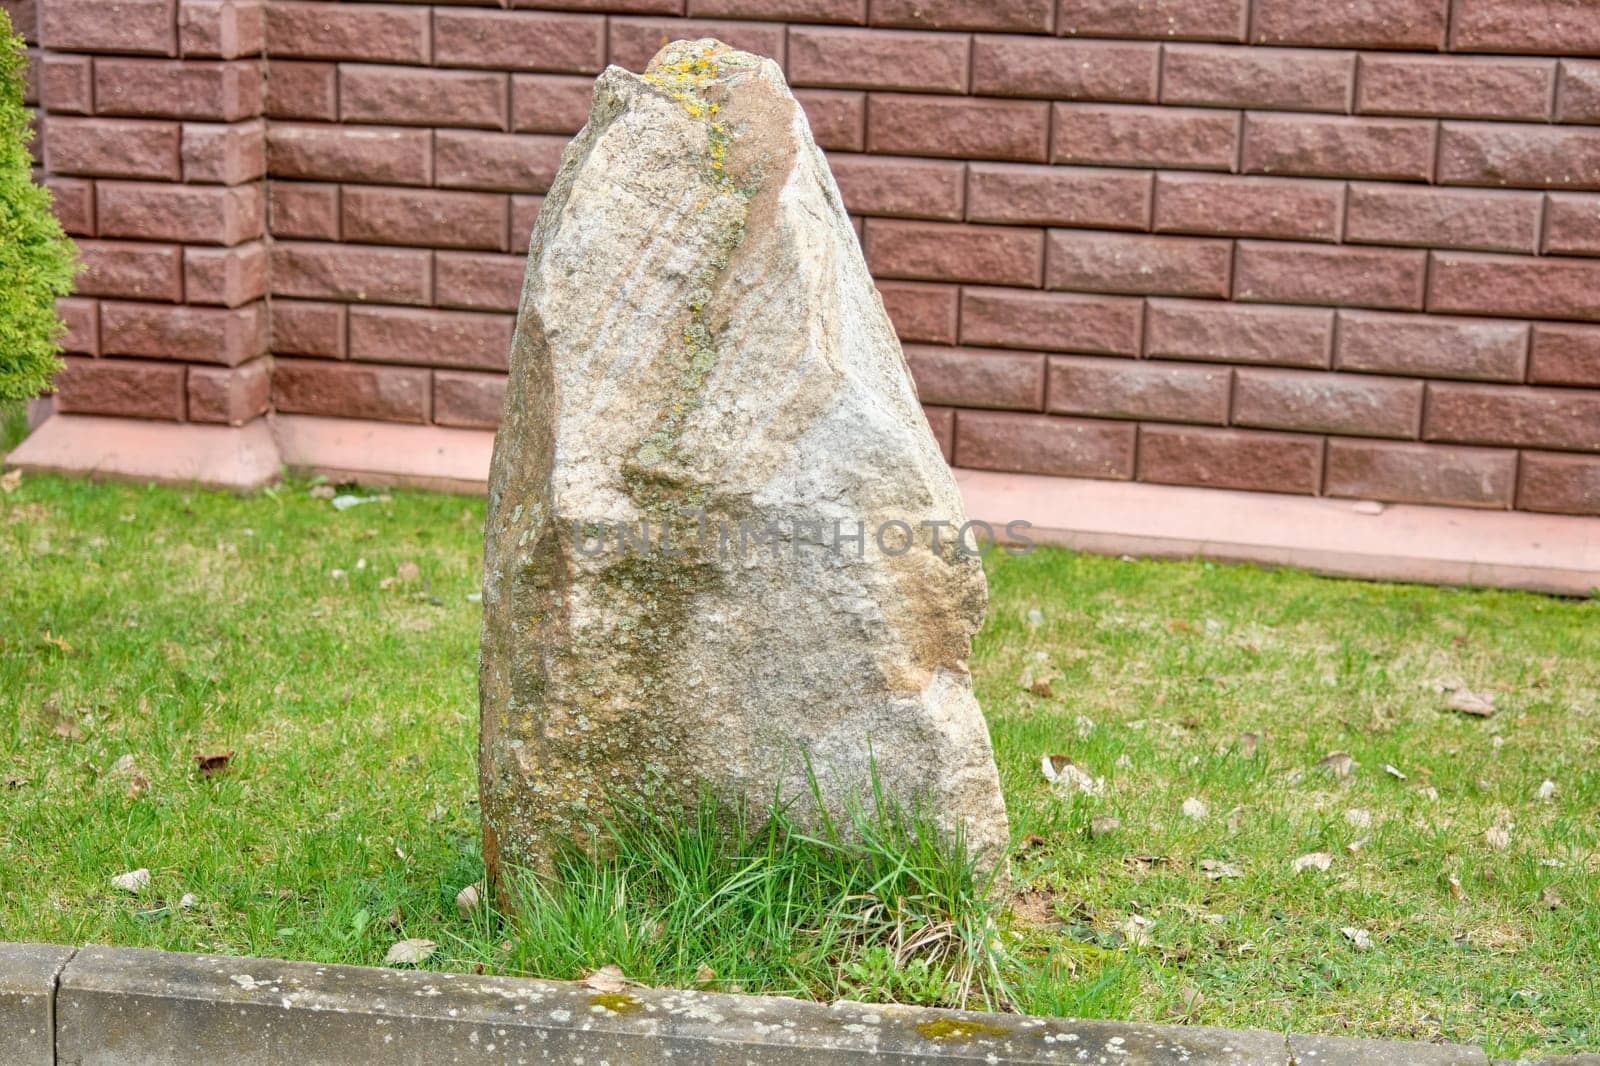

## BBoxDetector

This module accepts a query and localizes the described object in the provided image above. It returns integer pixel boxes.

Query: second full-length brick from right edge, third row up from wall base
[1144,299,1333,367]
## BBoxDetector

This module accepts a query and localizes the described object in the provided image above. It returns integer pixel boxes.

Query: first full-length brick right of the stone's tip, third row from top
[867,93,1050,163]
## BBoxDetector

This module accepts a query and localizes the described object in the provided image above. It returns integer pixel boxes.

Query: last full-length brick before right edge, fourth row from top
[1344,182,1541,253]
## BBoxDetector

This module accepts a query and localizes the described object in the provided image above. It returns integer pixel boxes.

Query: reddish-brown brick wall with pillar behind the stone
[3,0,1600,514]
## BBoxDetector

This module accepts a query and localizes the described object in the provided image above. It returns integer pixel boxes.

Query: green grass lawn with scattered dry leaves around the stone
[0,479,1600,1056]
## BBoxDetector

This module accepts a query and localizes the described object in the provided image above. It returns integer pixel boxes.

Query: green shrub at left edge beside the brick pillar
[0,8,77,405]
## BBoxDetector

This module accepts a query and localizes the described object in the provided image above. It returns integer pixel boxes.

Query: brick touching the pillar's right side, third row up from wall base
[272,240,434,304]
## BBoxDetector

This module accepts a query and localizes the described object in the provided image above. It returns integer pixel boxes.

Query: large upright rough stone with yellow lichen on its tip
[480,40,1006,869]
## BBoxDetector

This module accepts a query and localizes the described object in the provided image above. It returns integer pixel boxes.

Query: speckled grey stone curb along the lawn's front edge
[0,944,1574,1066]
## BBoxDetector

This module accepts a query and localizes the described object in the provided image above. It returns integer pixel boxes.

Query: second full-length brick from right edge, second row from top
[1162,45,1355,112]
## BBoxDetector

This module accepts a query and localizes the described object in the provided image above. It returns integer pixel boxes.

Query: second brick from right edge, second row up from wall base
[1234,367,1422,437]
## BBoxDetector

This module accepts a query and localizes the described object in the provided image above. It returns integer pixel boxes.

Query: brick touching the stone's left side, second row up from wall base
[350,307,512,370]
